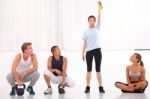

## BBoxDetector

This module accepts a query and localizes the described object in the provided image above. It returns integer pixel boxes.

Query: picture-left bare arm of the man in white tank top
[12,54,22,82]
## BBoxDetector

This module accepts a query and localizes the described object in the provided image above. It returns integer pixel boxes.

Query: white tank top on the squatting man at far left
[16,54,32,73]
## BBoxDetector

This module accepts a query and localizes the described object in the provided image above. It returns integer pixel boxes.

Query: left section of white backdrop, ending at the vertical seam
[0,0,58,50]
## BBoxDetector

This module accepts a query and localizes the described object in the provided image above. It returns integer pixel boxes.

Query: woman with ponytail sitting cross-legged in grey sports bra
[115,53,148,93]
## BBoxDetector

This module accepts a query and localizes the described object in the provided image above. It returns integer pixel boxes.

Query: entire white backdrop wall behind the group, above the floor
[0,0,150,51]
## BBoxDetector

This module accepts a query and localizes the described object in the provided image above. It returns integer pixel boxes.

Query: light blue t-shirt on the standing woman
[82,24,101,51]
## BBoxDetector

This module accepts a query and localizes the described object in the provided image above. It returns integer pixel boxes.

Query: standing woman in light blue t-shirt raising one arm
[82,1,105,93]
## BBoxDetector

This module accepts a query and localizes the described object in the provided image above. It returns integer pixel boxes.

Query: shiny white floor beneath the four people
[0,50,150,99]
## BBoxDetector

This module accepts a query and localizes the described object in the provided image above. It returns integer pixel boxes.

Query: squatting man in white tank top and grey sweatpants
[7,42,40,95]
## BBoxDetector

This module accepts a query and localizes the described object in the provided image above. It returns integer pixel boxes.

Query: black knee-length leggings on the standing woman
[86,48,102,72]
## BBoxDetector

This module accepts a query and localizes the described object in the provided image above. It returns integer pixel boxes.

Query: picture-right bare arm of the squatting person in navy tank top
[61,57,67,85]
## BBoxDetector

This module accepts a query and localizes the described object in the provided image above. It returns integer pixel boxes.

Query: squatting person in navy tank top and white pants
[44,46,74,94]
